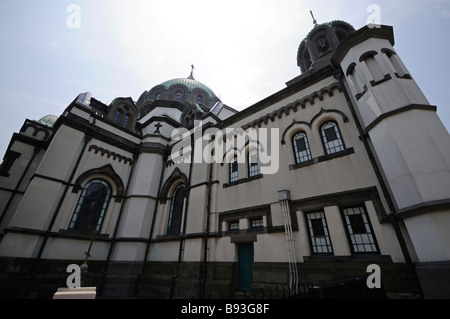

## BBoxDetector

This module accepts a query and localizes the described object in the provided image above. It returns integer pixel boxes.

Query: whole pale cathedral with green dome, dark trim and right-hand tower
[0,21,450,298]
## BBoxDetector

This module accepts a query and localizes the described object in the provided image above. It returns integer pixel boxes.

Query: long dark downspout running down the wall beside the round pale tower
[333,66,423,299]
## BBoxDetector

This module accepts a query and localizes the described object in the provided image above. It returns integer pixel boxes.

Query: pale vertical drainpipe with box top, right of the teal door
[278,190,298,296]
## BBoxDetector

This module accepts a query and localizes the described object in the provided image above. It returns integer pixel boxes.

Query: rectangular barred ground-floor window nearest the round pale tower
[342,206,379,253]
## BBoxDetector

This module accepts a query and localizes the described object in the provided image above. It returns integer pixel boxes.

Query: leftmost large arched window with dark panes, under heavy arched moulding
[69,179,111,232]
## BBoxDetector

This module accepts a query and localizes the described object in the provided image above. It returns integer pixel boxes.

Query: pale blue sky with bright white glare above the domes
[0,0,450,156]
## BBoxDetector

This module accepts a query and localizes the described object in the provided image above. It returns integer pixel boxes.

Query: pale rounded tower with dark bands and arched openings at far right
[332,26,450,271]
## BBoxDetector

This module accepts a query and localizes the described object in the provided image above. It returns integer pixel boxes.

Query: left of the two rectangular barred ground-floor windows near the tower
[306,211,333,255]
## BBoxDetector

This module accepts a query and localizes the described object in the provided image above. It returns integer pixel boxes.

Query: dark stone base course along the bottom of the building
[0,257,442,299]
